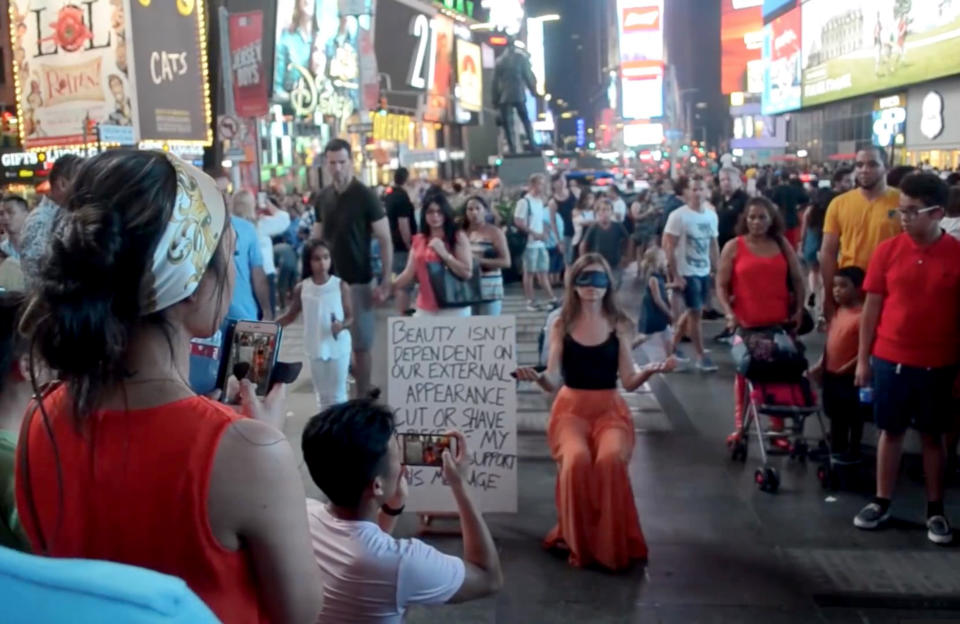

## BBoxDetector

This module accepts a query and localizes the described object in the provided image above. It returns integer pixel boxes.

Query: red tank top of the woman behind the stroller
[731,236,790,327]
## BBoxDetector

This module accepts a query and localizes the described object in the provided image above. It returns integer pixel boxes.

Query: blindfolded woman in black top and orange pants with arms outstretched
[517,253,676,570]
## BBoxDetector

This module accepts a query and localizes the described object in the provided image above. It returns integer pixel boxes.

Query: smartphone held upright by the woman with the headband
[218,321,282,397]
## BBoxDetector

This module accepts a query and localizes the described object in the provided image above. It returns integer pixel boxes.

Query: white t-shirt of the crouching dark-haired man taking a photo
[307,498,466,624]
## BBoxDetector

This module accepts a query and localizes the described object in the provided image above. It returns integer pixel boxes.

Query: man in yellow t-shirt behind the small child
[820,145,901,321]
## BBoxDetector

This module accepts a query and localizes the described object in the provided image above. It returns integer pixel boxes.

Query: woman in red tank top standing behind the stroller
[717,197,806,443]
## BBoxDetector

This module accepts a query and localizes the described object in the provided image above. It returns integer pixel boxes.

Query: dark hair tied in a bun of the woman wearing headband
[24,150,177,415]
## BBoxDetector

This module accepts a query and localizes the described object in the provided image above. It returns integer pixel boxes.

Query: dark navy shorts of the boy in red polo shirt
[871,357,957,435]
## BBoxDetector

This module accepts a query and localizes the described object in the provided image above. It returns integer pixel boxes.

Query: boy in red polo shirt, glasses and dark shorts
[853,173,960,544]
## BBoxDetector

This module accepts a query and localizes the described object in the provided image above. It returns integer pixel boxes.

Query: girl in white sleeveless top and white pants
[277,239,353,409]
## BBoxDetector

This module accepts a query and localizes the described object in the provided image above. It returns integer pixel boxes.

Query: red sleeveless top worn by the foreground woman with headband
[16,386,266,624]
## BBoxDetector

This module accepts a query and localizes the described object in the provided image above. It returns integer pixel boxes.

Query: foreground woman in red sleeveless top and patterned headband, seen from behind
[16,151,321,623]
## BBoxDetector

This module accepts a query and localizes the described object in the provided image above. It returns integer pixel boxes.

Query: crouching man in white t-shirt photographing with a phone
[302,400,503,624]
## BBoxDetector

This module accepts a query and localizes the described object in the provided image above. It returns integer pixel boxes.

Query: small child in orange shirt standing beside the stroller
[810,266,870,462]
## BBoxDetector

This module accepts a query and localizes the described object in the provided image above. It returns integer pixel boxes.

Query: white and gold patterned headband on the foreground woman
[140,152,227,316]
